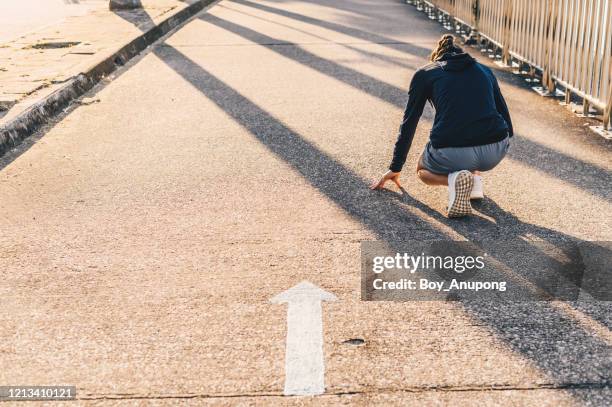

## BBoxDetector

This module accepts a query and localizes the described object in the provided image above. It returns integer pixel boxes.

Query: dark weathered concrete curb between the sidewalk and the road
[0,0,215,157]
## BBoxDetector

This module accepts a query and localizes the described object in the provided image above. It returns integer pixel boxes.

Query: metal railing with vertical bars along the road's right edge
[411,0,612,129]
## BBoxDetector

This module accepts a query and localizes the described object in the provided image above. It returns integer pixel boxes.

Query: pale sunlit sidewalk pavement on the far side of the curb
[0,0,206,115]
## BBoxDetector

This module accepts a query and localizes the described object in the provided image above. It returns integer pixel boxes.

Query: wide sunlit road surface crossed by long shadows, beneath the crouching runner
[0,0,612,406]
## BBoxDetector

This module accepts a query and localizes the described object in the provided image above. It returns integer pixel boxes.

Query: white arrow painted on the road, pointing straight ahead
[270,281,337,396]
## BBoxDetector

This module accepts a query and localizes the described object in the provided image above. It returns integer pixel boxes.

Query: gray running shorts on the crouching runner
[420,137,510,174]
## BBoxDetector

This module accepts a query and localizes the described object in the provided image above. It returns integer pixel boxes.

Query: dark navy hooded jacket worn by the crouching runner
[389,52,513,172]
